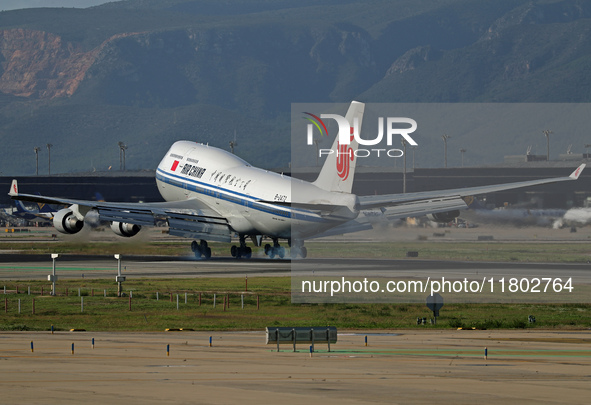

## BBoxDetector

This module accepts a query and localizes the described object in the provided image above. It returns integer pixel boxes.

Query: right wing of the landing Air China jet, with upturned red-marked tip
[358,164,585,219]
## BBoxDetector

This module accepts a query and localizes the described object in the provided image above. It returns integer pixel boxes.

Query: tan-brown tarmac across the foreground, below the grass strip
[0,330,591,405]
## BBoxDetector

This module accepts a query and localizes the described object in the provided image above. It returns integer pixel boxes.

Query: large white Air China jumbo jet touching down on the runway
[9,101,585,259]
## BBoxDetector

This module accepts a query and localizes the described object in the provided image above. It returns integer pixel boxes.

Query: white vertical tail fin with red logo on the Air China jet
[314,101,365,193]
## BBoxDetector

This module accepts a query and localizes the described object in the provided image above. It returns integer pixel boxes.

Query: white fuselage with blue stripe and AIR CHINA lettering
[156,141,358,239]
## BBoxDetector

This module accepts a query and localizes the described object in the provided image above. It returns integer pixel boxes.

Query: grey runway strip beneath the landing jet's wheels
[0,254,591,284]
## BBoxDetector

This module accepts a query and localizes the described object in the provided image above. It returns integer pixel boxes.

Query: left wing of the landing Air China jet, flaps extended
[9,181,231,242]
